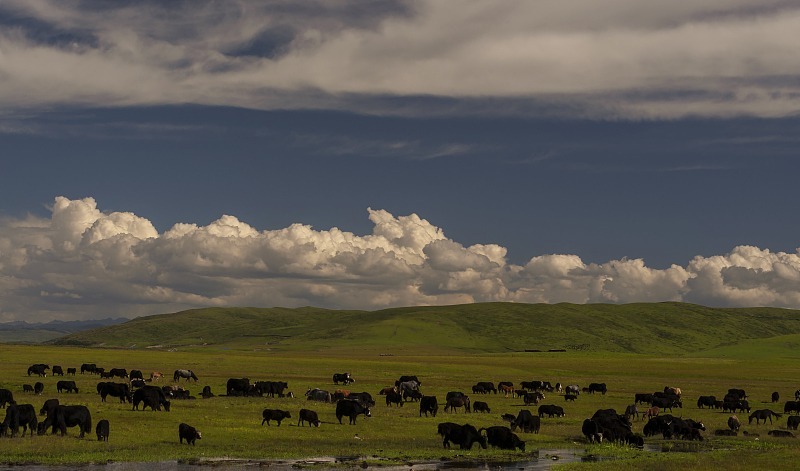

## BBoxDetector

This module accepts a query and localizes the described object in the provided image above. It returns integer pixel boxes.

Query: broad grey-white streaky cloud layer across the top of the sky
[0,0,800,118]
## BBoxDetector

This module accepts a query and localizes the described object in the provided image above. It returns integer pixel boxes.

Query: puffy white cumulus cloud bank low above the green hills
[0,197,800,321]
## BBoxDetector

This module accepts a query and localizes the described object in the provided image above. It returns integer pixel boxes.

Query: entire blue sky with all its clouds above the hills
[0,0,800,322]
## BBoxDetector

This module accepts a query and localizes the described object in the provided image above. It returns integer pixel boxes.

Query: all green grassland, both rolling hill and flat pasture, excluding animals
[0,303,800,470]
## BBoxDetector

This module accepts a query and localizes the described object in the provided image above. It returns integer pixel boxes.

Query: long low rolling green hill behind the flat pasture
[48,303,800,355]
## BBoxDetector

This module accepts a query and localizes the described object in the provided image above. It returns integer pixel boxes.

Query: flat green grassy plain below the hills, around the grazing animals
[0,342,800,470]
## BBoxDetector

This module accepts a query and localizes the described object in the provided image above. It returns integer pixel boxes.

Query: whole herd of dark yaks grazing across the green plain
[0,364,800,451]
